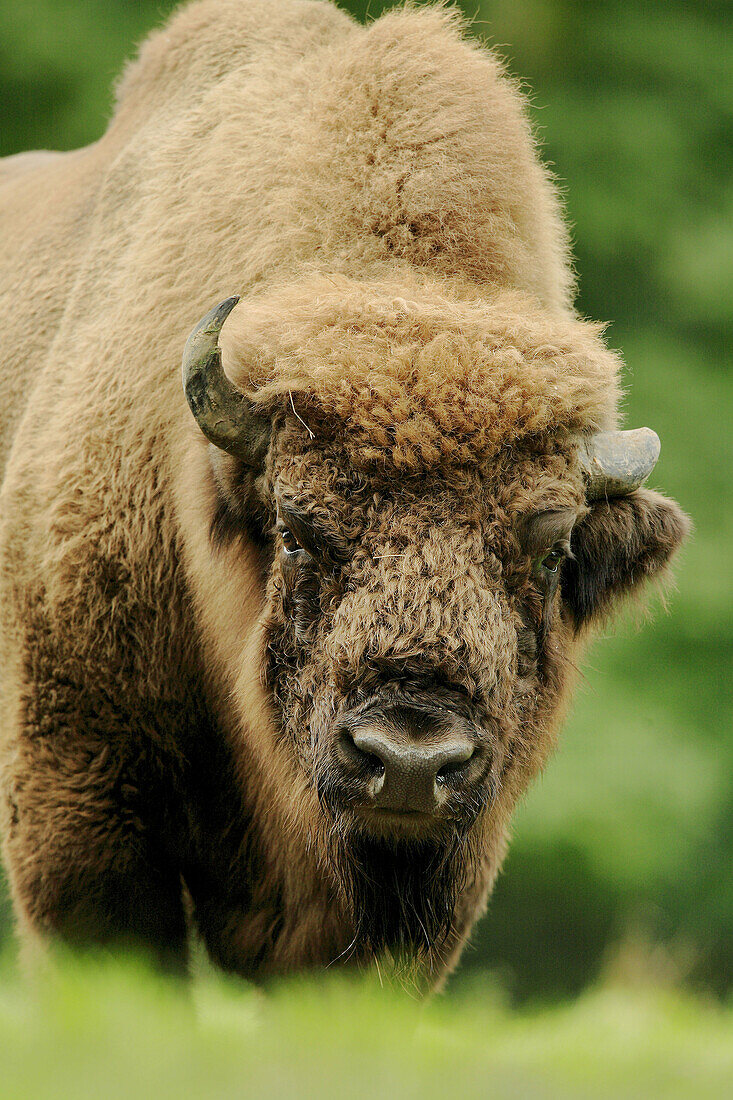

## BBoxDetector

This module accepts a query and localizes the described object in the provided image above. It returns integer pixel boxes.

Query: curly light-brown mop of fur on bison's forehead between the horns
[222,277,619,471]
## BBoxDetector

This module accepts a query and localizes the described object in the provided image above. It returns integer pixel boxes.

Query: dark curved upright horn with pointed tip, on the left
[182,297,271,466]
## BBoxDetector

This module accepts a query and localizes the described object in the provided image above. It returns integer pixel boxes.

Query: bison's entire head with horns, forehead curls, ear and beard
[179,284,685,968]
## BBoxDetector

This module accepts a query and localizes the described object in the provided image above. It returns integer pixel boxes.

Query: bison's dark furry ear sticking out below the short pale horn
[562,490,690,628]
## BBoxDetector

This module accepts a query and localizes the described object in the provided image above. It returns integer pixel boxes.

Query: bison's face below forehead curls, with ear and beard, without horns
[256,424,682,947]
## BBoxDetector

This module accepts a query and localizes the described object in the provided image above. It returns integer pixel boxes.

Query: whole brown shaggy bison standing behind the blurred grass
[0,0,687,987]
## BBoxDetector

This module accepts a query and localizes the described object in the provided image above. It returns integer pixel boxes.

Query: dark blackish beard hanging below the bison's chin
[338,829,474,961]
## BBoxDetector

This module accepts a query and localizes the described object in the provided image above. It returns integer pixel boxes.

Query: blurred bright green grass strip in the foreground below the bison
[0,958,733,1100]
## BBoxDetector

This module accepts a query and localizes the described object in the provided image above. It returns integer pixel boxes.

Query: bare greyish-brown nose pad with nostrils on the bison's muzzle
[349,727,473,813]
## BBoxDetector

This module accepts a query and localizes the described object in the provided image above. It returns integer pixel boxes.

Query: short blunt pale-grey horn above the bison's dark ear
[578,428,660,501]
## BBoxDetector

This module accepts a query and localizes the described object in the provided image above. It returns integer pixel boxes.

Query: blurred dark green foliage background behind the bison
[0,0,733,1000]
